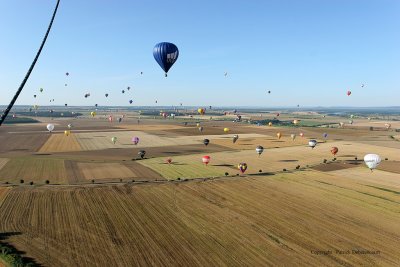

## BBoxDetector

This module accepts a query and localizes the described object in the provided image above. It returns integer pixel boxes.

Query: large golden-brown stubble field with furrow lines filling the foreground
[0,170,400,266]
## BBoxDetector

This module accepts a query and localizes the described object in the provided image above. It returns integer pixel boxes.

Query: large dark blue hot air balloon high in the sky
[153,42,179,77]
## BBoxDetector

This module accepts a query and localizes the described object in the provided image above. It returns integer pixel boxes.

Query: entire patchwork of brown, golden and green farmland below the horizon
[0,114,400,266]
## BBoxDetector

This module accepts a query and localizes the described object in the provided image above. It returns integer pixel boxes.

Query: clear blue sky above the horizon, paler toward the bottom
[0,0,400,107]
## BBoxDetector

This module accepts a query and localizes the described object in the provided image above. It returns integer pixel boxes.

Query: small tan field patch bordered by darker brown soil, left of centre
[78,162,136,180]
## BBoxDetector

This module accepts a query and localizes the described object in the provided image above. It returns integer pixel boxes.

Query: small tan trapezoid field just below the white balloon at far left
[39,133,81,153]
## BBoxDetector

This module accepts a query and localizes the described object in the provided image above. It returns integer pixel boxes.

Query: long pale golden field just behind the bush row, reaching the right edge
[139,141,400,179]
